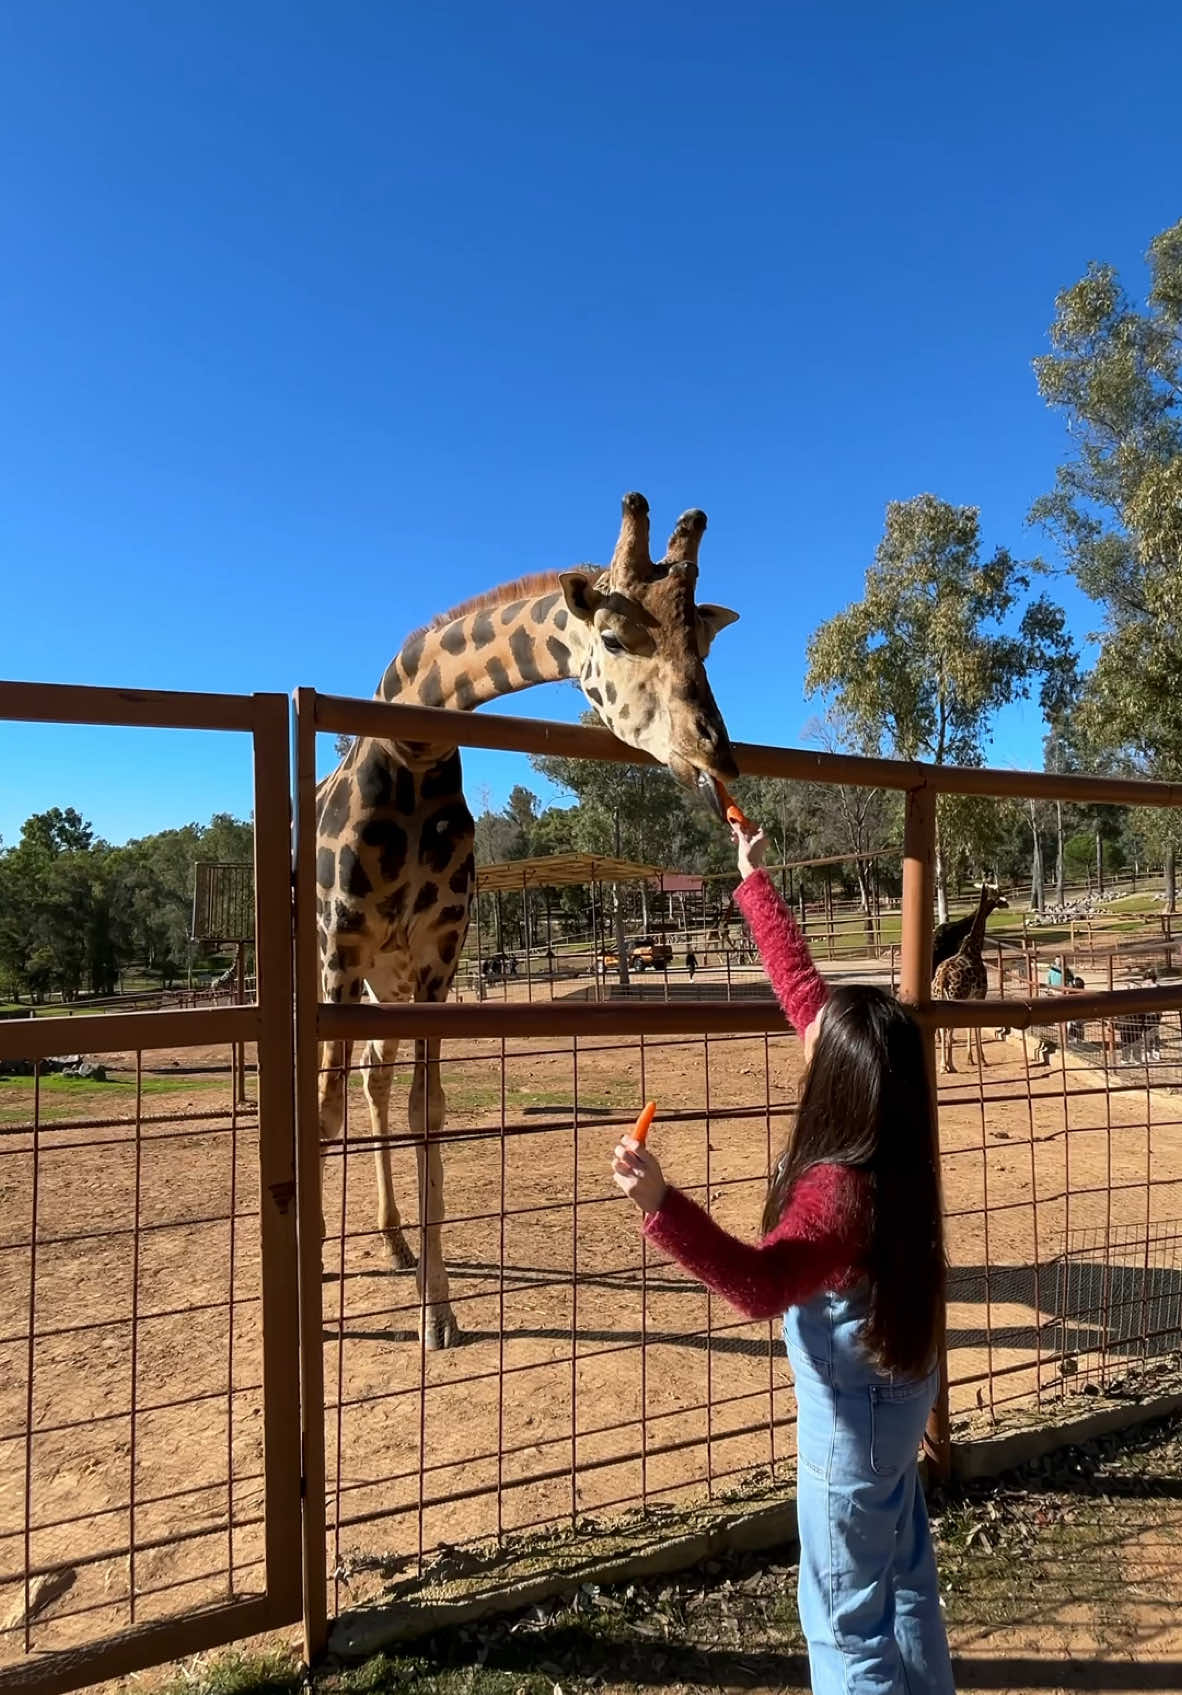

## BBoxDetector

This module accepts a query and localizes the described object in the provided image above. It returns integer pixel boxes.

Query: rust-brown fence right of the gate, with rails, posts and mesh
[297,690,1182,1648]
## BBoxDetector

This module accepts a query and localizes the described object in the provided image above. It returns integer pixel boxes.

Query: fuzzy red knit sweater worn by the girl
[644,870,870,1319]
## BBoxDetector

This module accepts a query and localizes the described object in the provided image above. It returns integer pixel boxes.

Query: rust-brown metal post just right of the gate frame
[292,688,329,1664]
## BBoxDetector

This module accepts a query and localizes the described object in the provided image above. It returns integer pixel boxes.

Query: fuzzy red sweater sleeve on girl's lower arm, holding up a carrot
[644,1164,865,1319]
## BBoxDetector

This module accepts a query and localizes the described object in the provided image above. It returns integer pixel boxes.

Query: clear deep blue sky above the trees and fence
[0,0,1182,841]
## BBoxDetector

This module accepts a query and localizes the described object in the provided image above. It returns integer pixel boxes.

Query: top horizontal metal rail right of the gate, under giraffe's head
[307,690,1182,807]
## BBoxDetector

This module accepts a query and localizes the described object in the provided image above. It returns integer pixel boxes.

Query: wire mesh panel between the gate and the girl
[313,1036,800,1610]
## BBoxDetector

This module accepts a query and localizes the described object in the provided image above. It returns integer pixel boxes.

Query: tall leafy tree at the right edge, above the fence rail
[1031,222,1182,778]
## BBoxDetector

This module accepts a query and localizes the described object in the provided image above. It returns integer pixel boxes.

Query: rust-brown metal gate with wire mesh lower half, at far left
[0,683,300,1695]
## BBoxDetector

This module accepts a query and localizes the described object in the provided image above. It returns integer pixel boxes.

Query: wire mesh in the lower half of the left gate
[0,1048,265,1661]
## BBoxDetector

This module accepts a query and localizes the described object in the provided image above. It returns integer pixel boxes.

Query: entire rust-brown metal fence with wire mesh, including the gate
[0,671,1182,1690]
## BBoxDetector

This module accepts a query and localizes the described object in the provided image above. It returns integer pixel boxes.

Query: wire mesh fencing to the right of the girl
[939,1002,1182,1431]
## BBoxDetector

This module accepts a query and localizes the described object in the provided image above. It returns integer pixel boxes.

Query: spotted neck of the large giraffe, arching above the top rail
[378,578,583,710]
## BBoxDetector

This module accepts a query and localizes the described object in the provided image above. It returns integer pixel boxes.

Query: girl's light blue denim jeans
[783,1295,953,1695]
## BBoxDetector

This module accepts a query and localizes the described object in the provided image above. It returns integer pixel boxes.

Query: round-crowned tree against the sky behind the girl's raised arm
[806,495,1075,922]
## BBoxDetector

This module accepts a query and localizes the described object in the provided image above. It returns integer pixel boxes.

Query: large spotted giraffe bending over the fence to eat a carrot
[315,493,738,1349]
